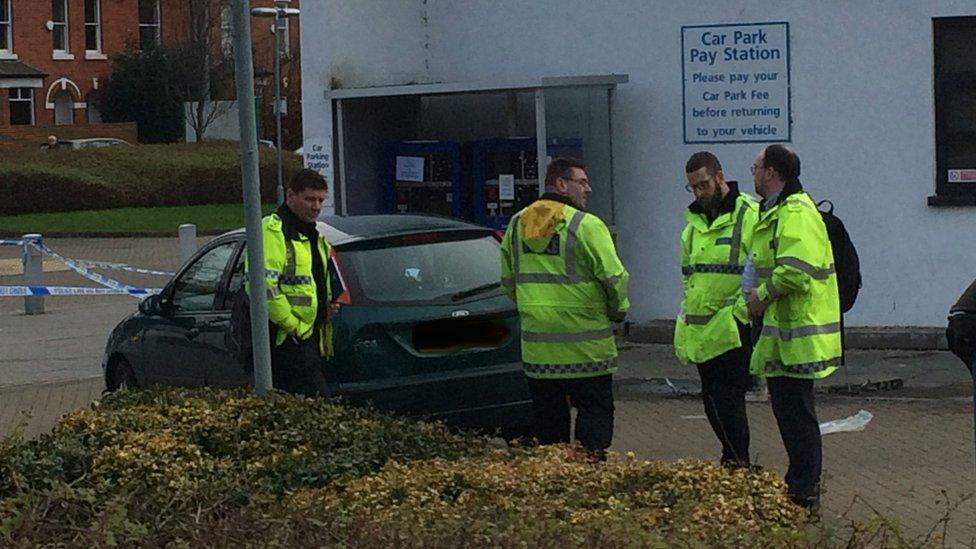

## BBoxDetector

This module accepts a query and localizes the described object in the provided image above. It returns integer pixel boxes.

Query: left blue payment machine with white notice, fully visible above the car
[384,141,462,218]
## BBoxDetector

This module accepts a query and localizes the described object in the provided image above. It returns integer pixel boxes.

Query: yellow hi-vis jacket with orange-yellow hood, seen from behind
[501,195,630,379]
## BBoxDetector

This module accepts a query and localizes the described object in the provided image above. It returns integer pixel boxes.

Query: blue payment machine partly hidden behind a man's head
[465,137,583,229]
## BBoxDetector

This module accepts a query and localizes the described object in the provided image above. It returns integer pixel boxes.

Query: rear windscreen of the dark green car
[340,233,501,304]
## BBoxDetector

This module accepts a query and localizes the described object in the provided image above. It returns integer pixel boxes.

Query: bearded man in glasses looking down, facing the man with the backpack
[674,151,758,467]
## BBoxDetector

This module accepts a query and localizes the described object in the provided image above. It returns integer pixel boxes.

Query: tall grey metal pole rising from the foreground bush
[231,0,272,396]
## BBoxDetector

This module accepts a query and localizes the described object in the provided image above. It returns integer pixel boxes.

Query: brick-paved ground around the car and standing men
[0,239,976,546]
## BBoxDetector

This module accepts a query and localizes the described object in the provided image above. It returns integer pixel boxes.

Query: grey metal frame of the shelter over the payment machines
[325,74,630,215]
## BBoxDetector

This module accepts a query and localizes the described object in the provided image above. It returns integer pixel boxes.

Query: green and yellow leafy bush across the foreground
[0,389,828,547]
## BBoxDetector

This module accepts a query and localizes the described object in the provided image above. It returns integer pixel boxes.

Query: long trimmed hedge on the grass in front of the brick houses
[0,141,302,214]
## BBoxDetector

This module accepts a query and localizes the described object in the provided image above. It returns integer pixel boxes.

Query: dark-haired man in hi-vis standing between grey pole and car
[248,169,338,396]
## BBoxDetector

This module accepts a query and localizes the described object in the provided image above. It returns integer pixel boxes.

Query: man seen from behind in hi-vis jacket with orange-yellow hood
[501,158,630,456]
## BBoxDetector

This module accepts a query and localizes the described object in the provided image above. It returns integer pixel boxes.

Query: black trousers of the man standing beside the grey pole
[271,331,331,396]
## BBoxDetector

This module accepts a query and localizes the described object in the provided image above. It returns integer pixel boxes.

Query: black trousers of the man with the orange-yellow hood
[528,374,614,452]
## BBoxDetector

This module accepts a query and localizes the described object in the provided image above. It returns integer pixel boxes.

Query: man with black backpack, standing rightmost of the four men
[746,145,841,512]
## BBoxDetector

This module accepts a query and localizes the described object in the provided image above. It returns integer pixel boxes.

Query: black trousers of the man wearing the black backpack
[766,377,823,506]
